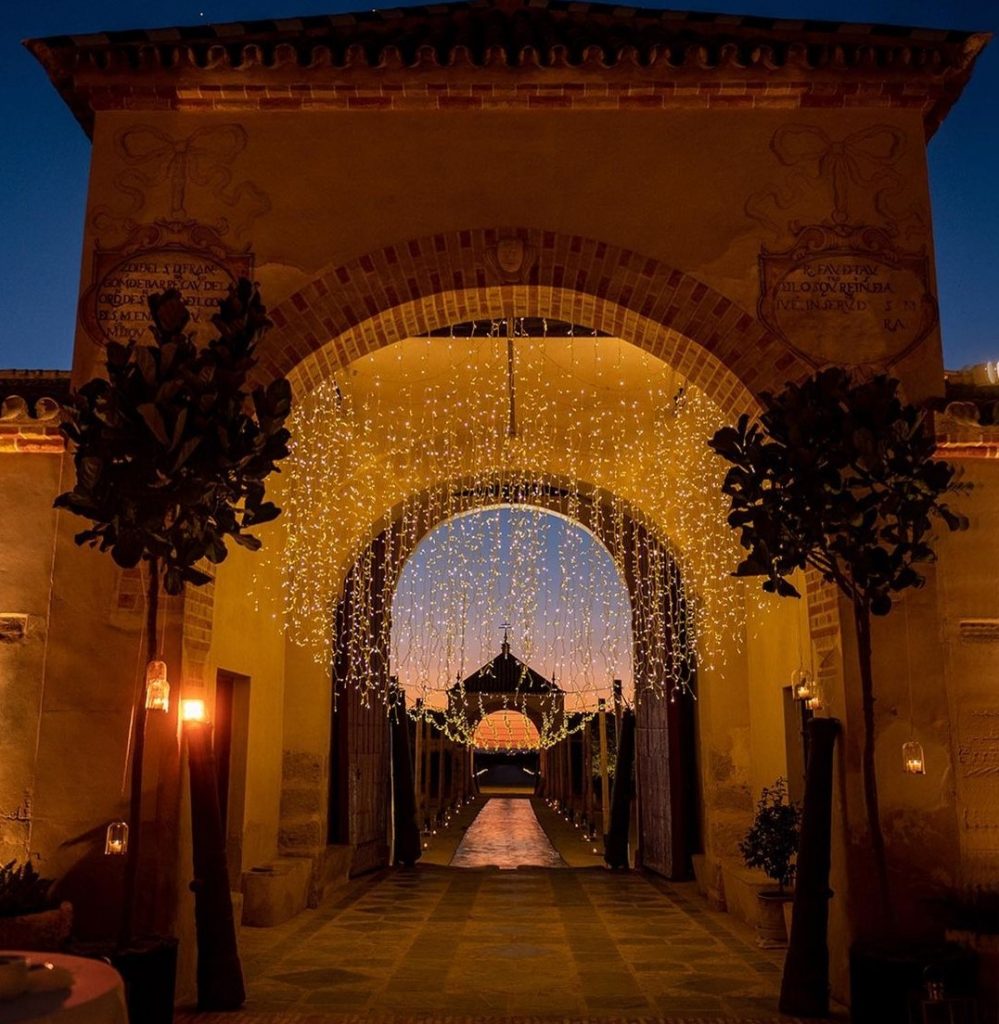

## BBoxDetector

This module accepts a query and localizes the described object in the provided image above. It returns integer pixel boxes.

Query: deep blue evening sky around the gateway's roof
[0,0,999,369]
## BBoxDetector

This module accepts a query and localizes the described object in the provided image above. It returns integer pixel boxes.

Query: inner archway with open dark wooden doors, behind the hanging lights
[330,479,700,878]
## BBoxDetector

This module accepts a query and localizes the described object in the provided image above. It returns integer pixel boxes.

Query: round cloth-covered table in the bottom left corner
[0,949,128,1024]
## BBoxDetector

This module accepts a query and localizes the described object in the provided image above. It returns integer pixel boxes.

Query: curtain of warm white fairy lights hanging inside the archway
[270,325,746,741]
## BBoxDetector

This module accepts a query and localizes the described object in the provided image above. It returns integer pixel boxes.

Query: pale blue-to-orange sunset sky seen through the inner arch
[392,506,633,716]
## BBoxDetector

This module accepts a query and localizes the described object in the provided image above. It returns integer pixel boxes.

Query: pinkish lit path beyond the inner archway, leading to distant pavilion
[450,797,565,868]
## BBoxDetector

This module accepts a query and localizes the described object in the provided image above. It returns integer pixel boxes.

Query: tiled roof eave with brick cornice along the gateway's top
[26,0,990,136]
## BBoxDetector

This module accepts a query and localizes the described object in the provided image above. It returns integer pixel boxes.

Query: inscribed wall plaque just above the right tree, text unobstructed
[759,226,938,367]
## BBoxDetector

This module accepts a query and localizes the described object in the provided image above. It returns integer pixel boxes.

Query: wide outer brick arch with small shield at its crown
[261,228,812,412]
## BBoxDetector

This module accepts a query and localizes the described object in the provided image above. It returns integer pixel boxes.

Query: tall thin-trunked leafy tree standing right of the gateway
[708,367,964,1024]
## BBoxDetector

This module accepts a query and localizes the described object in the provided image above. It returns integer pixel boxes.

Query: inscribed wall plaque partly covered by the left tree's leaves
[80,222,253,344]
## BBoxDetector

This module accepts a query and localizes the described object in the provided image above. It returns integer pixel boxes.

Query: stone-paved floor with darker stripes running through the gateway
[178,800,831,1024]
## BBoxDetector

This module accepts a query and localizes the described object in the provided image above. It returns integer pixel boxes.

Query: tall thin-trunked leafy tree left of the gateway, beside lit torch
[55,279,291,1021]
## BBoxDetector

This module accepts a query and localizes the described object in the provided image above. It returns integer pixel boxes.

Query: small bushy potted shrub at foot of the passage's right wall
[739,778,801,948]
